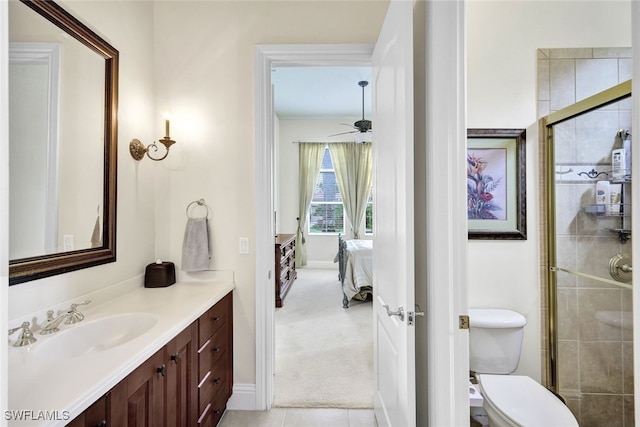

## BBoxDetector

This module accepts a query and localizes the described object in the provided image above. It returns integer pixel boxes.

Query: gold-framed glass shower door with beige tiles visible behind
[544,82,634,426]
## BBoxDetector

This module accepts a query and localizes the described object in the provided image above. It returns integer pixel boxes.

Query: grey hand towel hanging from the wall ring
[182,217,211,271]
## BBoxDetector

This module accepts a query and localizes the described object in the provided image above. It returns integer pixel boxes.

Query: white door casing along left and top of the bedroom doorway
[255,45,373,409]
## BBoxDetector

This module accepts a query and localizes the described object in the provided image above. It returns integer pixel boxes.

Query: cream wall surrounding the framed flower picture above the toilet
[467,0,631,380]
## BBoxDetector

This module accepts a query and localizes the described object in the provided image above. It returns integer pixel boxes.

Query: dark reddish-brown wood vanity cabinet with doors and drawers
[68,292,233,427]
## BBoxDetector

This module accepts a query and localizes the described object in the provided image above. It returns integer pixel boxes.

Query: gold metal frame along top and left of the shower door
[539,80,631,392]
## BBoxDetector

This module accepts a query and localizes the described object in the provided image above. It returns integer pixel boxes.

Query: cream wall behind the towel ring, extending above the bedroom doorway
[154,1,387,384]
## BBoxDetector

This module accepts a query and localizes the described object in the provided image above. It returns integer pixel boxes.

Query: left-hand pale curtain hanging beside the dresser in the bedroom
[296,143,325,267]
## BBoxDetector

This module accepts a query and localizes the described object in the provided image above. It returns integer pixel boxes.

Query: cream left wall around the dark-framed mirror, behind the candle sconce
[6,1,163,320]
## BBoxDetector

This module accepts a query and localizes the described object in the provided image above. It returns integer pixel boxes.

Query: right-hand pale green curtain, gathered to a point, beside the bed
[329,142,373,239]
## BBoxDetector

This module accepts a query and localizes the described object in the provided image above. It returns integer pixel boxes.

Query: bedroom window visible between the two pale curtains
[308,147,344,234]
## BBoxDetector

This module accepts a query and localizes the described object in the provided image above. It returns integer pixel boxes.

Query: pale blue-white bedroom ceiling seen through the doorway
[271,67,371,120]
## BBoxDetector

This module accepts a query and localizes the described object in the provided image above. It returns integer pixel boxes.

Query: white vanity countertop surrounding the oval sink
[2,280,235,427]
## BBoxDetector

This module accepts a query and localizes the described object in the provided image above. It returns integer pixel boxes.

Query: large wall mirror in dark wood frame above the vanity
[9,0,118,285]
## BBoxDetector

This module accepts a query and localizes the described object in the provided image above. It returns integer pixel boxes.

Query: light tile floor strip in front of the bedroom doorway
[219,408,378,427]
